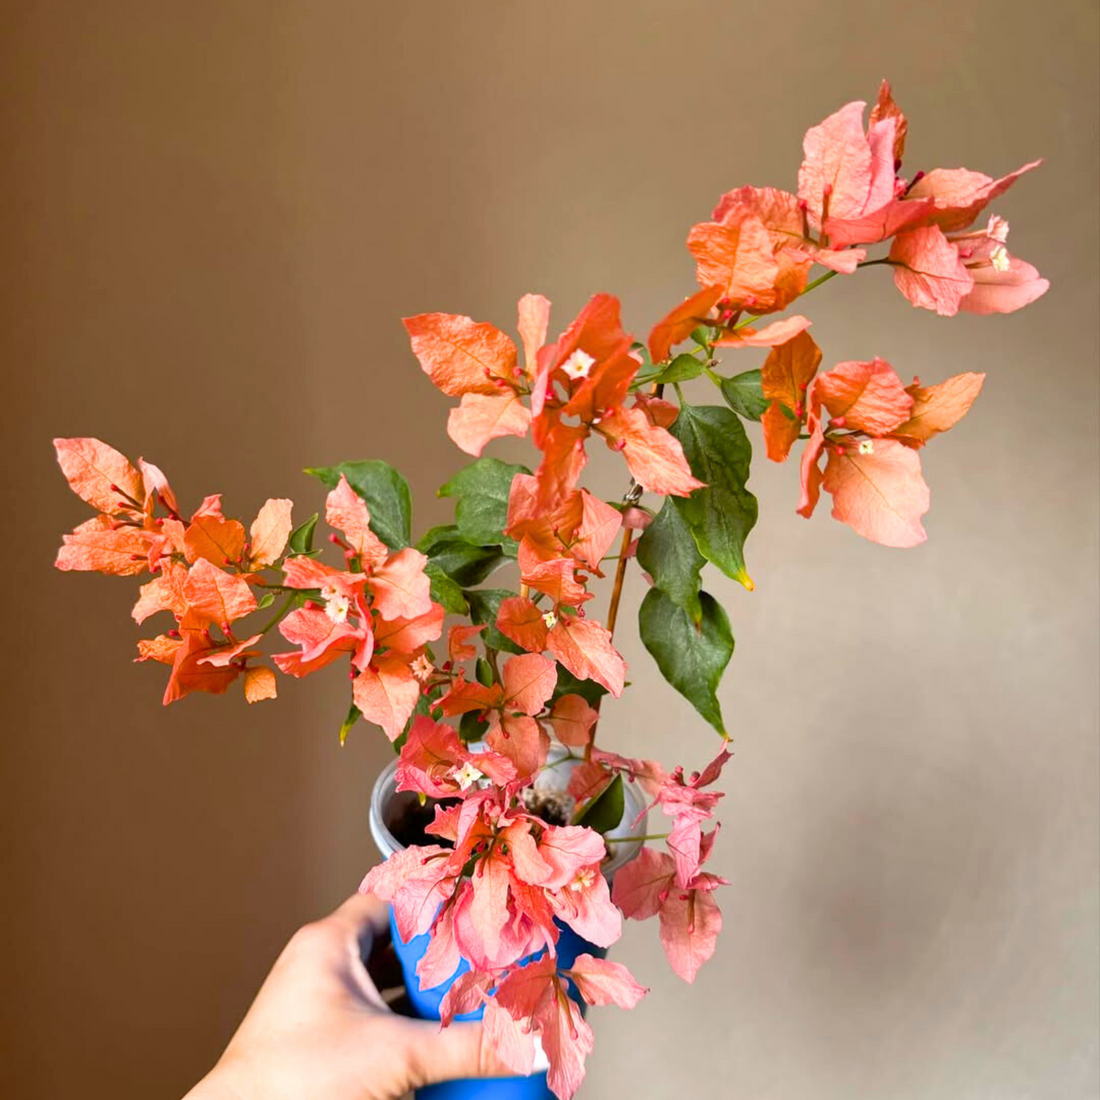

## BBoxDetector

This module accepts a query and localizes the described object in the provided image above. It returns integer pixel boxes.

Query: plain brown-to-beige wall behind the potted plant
[0,0,1100,1100]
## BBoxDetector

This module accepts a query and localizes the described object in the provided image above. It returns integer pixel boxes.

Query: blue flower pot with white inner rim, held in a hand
[371,746,646,1100]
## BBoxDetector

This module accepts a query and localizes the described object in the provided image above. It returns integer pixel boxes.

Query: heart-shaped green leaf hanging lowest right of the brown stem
[638,589,734,735]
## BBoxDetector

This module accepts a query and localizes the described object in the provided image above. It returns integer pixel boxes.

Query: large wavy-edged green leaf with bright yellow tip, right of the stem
[669,405,758,589]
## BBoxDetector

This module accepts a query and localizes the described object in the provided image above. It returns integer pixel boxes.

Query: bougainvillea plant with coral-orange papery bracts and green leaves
[56,85,1047,1098]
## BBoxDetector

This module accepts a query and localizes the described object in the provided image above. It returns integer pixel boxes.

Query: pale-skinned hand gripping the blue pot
[184,894,508,1100]
